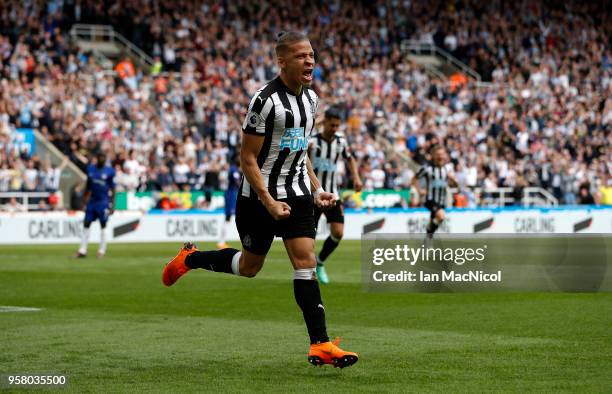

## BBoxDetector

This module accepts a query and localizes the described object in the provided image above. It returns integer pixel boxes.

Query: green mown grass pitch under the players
[0,241,612,393]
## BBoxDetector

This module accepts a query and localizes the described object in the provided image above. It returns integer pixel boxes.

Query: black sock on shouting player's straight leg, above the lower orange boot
[293,279,329,343]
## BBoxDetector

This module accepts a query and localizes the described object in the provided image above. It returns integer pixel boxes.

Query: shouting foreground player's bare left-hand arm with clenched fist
[240,133,291,220]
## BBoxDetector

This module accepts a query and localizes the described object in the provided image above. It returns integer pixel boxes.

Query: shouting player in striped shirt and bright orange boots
[162,32,358,368]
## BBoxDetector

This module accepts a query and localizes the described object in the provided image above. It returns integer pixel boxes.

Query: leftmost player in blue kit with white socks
[77,153,115,257]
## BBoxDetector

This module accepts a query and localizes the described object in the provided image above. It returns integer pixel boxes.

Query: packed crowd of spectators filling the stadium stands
[0,0,612,209]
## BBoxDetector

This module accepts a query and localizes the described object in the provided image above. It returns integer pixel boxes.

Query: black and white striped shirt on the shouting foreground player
[240,77,319,199]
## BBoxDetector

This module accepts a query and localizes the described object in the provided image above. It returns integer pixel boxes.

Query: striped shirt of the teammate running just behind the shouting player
[310,134,353,197]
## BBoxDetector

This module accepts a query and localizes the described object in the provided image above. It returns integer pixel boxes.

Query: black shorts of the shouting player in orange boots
[236,195,316,255]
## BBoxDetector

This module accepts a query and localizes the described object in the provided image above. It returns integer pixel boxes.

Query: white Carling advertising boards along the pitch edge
[0,206,612,244]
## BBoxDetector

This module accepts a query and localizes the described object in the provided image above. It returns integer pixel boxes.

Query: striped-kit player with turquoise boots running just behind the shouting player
[309,107,363,284]
